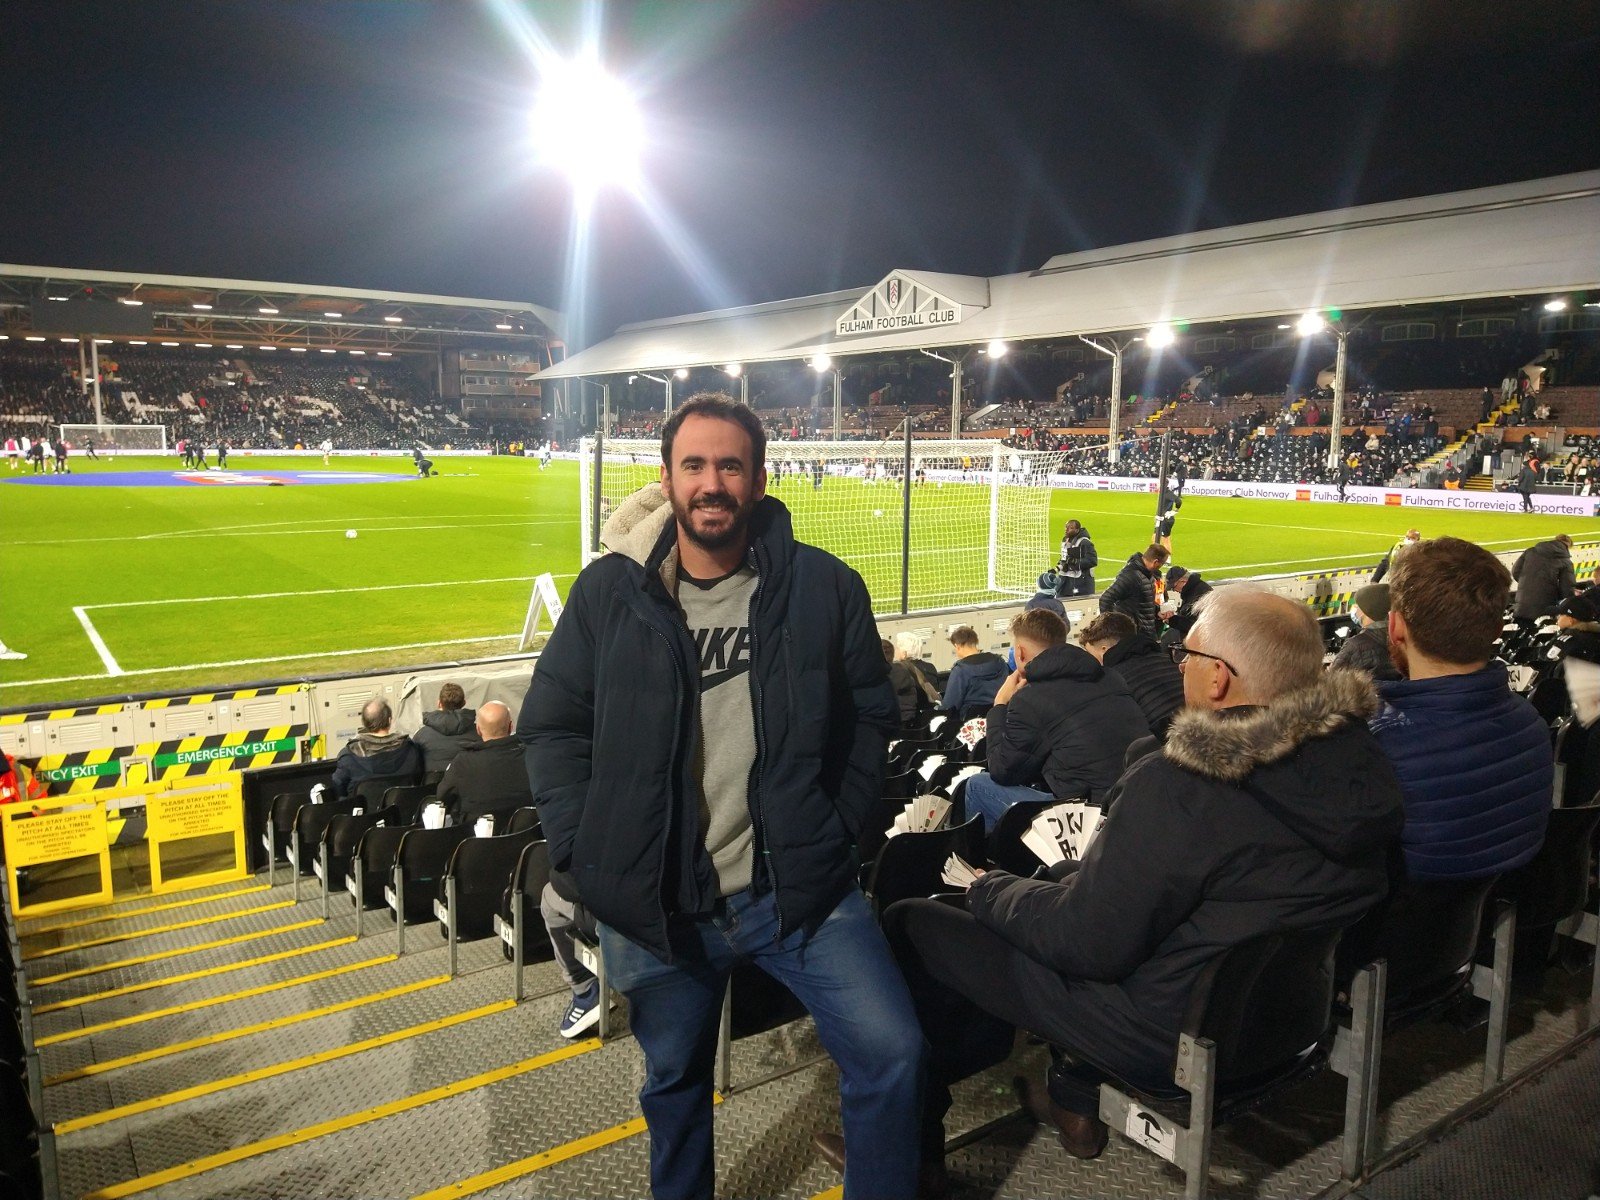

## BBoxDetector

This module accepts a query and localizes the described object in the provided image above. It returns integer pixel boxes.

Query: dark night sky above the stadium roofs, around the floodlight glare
[0,0,1600,341]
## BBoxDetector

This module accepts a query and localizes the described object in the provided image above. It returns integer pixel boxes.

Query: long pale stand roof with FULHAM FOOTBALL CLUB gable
[539,171,1600,379]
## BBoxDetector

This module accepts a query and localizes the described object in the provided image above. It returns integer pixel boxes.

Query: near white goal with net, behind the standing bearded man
[578,438,1062,613]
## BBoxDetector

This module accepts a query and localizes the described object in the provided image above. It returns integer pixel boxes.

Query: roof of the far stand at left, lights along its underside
[0,262,565,352]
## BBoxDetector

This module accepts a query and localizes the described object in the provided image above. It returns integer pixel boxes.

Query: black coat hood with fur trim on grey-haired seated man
[1163,670,1405,861]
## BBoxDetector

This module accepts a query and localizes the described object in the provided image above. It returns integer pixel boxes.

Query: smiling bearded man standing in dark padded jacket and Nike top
[517,394,922,1200]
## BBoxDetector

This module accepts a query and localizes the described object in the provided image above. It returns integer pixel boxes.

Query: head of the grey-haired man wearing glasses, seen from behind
[1184,584,1322,709]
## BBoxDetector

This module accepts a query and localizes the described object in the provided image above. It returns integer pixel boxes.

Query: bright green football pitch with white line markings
[0,454,1580,707]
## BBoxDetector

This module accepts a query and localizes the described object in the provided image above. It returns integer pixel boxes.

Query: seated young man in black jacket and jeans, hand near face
[966,610,1150,829]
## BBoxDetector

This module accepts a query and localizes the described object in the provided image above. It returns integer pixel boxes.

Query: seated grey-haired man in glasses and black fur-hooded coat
[885,586,1403,1178]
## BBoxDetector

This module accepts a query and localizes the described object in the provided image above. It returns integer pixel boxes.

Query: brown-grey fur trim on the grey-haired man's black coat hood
[1165,670,1378,784]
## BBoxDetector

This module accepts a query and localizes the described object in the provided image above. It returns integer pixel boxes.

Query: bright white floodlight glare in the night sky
[533,54,645,198]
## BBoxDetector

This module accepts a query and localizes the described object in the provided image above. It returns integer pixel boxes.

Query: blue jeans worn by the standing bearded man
[600,890,925,1200]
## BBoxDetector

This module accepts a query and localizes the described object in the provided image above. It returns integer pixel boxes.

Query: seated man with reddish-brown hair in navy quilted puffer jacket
[1371,538,1555,880]
